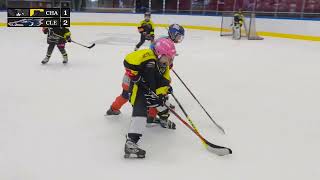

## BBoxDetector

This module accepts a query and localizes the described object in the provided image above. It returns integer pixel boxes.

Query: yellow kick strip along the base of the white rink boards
[0,22,320,41]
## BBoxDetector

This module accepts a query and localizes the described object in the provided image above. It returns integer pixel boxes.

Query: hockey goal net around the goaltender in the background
[220,12,263,40]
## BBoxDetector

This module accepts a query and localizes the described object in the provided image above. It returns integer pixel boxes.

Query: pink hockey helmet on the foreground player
[154,38,176,60]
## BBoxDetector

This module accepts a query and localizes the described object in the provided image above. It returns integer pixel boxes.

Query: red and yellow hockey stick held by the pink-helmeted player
[141,83,232,156]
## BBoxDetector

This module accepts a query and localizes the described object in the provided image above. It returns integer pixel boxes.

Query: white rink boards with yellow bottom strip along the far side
[0,12,320,41]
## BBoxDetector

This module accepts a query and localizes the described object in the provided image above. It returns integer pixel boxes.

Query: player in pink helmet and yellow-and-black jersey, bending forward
[124,38,176,158]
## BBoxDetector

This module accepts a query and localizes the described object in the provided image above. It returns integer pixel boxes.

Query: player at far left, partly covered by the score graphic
[41,27,71,64]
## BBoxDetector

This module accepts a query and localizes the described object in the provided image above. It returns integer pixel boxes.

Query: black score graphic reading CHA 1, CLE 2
[8,8,70,27]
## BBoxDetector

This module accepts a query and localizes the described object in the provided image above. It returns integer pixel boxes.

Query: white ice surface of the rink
[0,27,320,180]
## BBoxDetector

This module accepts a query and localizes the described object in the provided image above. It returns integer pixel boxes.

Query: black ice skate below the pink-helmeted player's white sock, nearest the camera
[124,139,146,158]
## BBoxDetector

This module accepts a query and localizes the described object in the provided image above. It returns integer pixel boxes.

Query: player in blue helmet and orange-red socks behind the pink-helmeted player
[106,24,184,129]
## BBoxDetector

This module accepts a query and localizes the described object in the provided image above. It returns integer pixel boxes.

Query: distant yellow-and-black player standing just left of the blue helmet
[134,12,154,51]
